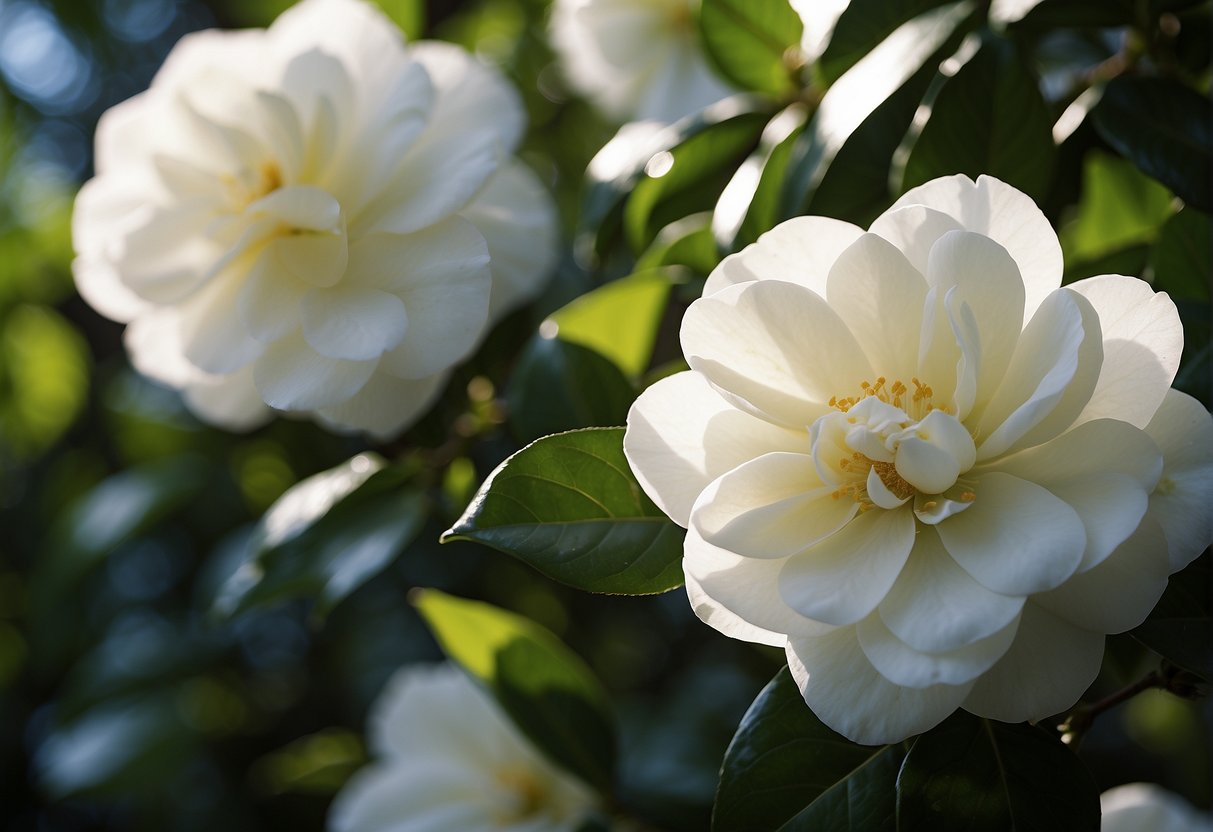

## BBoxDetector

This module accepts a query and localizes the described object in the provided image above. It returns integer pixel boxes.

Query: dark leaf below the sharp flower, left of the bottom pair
[712,667,902,832]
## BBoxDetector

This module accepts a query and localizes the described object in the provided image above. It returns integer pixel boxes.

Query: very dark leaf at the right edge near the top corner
[1090,75,1213,211]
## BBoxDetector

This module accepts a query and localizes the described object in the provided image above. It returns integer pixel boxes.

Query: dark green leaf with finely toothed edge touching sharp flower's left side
[443,428,684,594]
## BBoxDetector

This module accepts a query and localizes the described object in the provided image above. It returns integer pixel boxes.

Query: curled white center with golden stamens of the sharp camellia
[810,377,976,523]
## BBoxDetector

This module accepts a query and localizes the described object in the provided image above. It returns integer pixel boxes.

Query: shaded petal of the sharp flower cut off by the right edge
[1145,391,1213,572]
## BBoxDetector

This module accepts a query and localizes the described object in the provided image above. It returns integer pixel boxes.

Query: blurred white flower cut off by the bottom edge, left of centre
[329,665,598,832]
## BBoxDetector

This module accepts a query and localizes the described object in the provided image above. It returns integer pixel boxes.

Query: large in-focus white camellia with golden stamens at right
[625,176,1213,743]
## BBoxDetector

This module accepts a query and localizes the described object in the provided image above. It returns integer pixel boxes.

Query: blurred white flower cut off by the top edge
[552,0,734,124]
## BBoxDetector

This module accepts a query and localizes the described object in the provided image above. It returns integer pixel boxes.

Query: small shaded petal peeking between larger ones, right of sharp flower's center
[1048,473,1149,572]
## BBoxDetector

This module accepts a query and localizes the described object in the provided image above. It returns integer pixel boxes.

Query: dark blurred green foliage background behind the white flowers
[0,0,1213,832]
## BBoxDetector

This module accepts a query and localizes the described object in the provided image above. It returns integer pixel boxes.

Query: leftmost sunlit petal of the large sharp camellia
[623,372,809,526]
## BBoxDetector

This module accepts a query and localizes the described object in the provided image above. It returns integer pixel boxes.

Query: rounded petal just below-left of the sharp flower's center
[779,508,915,625]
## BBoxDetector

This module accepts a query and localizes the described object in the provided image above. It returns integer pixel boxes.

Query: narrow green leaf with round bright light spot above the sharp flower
[623,113,769,252]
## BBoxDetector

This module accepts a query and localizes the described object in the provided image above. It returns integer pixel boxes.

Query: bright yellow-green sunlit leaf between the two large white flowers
[545,270,671,377]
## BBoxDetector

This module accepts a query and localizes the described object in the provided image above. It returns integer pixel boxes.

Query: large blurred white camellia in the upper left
[73,0,556,435]
